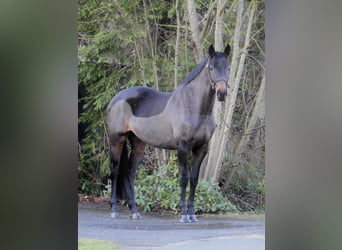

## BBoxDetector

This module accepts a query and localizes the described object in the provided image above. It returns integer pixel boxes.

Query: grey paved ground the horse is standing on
[78,203,265,250]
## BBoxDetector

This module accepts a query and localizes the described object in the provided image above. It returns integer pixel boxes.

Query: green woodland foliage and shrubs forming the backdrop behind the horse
[78,0,265,212]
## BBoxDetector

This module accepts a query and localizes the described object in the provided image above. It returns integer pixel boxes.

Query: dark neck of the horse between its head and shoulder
[184,67,215,115]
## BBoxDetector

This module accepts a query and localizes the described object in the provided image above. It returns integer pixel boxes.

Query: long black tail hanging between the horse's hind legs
[116,140,131,199]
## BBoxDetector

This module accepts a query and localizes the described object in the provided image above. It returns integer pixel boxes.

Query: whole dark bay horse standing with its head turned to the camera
[107,45,230,222]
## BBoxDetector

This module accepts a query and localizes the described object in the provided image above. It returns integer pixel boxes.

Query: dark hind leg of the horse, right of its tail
[128,133,146,219]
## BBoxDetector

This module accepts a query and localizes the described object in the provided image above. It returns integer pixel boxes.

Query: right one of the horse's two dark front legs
[188,144,208,222]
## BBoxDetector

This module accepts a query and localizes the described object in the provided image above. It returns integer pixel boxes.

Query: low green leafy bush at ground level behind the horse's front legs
[135,156,237,213]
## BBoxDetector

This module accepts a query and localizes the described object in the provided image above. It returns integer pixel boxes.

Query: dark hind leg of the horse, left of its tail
[110,135,127,219]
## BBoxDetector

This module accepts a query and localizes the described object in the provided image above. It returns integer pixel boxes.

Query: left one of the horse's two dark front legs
[178,143,190,223]
